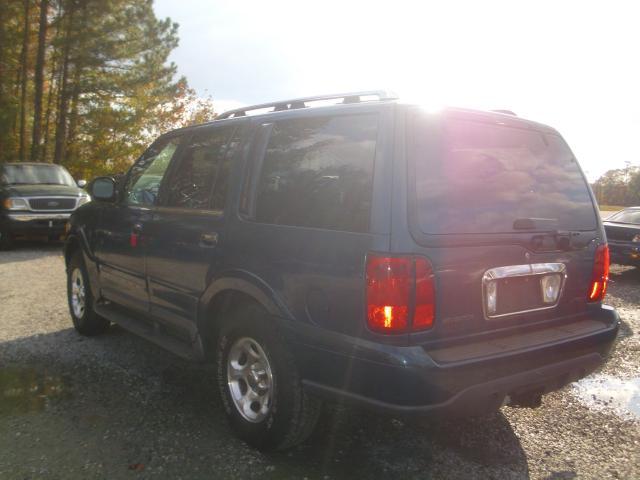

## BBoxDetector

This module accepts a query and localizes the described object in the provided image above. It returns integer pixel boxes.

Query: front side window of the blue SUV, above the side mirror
[126,137,180,205]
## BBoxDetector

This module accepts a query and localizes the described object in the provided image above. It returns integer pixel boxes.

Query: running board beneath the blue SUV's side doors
[94,303,200,361]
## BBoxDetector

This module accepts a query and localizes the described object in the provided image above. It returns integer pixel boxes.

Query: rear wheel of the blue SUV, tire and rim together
[216,305,321,451]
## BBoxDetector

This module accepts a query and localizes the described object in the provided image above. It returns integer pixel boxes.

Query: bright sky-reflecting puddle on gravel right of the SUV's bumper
[573,375,640,419]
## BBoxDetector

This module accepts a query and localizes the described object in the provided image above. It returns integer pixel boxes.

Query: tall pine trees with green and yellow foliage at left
[0,0,215,178]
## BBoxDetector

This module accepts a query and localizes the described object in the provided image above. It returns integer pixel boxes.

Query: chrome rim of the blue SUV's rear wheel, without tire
[227,337,273,423]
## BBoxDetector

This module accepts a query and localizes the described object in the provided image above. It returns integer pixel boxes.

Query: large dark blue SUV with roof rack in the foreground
[65,92,619,449]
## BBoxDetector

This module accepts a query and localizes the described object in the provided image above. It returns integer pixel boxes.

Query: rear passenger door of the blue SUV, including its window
[145,122,239,341]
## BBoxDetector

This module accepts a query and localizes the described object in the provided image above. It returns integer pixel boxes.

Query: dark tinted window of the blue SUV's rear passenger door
[168,128,230,209]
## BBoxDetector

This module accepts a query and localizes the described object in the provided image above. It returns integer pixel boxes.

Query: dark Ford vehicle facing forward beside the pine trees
[0,163,91,249]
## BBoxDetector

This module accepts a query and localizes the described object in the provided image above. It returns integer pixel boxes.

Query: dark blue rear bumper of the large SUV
[296,307,619,415]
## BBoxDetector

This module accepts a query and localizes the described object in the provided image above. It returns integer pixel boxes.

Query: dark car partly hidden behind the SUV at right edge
[603,207,640,267]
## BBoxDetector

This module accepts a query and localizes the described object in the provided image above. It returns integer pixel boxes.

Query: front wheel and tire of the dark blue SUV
[67,252,109,336]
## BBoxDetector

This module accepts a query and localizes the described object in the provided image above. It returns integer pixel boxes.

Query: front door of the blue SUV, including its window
[95,136,181,312]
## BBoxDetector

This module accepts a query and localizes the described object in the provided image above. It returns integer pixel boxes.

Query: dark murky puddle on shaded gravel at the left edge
[0,368,66,416]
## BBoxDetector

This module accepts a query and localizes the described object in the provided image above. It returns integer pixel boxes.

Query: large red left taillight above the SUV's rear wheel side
[366,254,435,333]
